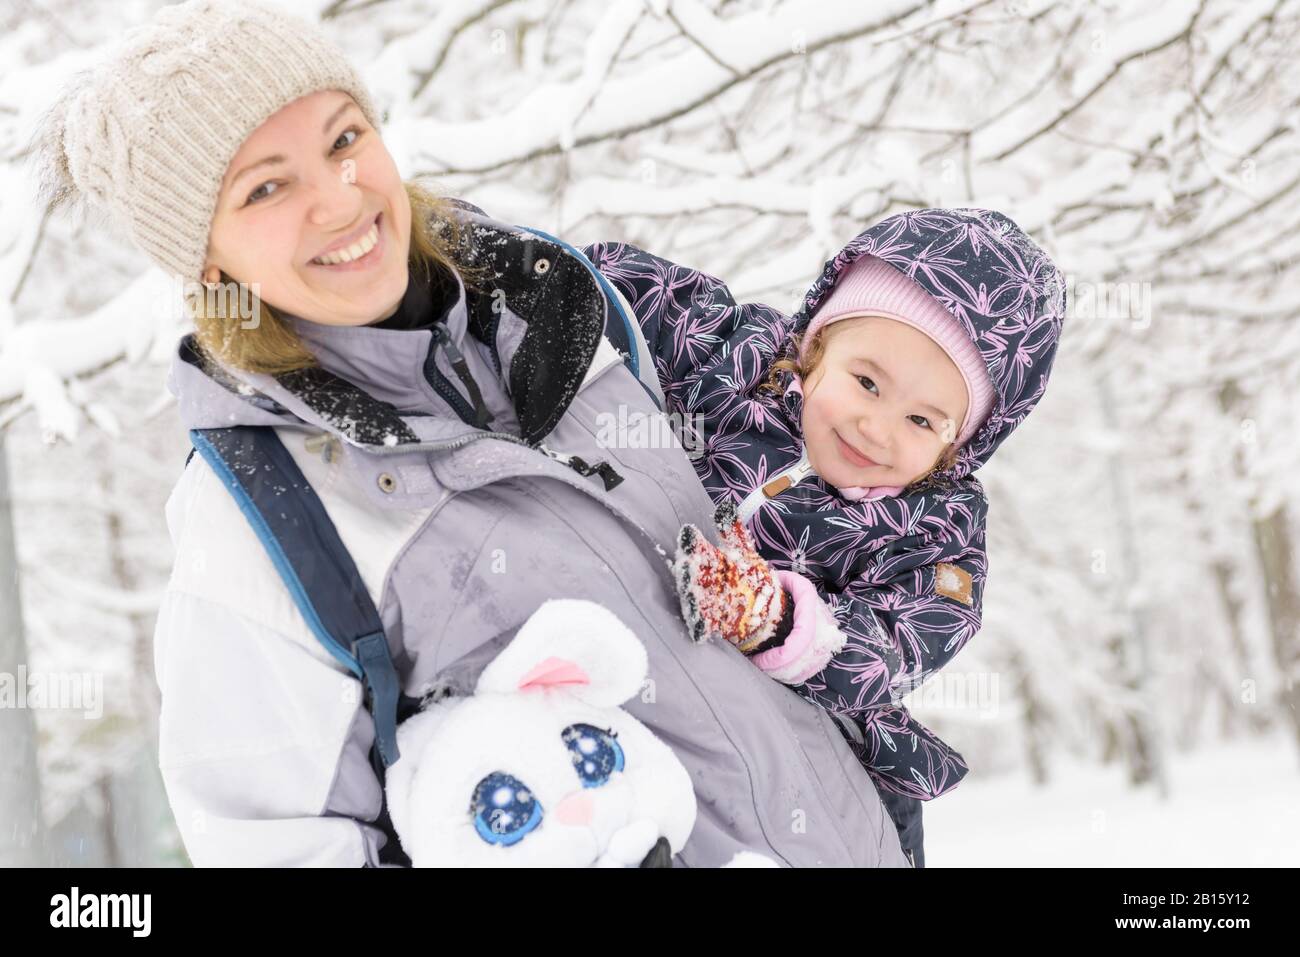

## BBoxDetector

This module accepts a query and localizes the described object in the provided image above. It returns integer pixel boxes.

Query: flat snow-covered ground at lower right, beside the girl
[924,733,1300,867]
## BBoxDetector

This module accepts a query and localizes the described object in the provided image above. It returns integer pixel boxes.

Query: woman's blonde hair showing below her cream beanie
[187,181,480,376]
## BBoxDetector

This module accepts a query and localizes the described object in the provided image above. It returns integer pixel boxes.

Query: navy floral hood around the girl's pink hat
[783,208,1066,480]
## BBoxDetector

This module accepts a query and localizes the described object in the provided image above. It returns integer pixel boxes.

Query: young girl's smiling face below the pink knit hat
[802,316,966,488]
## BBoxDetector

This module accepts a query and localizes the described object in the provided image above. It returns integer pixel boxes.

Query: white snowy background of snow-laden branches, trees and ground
[0,0,1300,866]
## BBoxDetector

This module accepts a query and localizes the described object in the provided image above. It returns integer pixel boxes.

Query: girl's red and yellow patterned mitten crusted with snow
[672,502,794,654]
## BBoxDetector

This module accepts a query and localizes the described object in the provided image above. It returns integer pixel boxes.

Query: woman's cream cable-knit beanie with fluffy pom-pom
[34,0,380,282]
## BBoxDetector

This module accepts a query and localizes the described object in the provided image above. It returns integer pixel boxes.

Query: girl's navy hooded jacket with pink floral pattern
[584,209,1065,800]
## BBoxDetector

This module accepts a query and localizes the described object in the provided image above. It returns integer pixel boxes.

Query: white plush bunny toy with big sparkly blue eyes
[387,598,774,867]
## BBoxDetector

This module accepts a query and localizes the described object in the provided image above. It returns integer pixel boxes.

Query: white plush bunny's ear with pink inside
[476,598,646,707]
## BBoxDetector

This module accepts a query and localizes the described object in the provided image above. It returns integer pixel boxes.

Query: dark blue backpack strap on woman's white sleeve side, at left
[186,425,403,769]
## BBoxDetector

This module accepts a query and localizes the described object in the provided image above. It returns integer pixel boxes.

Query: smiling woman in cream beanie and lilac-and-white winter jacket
[27,0,907,866]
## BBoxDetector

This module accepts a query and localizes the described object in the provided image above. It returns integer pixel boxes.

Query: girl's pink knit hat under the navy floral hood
[796,256,995,501]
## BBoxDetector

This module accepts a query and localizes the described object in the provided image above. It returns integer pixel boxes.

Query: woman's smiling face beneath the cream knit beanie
[204,90,411,325]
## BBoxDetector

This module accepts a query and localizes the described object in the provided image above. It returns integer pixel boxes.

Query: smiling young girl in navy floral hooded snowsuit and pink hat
[585,209,1065,866]
